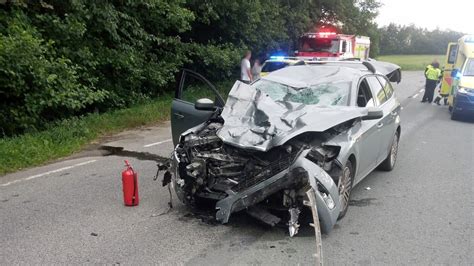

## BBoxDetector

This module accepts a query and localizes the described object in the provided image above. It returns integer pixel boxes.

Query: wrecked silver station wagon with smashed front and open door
[171,62,401,236]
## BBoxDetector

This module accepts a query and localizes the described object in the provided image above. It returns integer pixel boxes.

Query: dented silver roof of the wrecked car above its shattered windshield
[261,64,372,88]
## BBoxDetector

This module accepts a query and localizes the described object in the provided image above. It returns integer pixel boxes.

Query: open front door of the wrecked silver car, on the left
[171,69,225,146]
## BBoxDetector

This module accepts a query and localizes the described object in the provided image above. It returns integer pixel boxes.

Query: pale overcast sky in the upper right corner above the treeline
[376,0,474,34]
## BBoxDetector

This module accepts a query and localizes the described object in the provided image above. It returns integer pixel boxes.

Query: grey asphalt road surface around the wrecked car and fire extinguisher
[0,72,474,265]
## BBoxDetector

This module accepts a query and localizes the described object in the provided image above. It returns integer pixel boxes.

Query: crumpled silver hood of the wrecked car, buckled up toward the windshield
[217,81,367,151]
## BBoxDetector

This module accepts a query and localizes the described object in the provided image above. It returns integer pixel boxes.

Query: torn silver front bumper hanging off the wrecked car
[172,151,341,233]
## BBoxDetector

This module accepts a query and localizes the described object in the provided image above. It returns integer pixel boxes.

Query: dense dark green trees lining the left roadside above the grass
[0,0,379,135]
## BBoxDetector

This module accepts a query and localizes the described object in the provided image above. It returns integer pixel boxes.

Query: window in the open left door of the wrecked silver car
[181,74,216,103]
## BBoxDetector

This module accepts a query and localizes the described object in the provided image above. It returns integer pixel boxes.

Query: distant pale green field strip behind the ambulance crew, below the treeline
[377,55,445,70]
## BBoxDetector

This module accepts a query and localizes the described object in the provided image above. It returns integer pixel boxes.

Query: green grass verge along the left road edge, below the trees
[0,81,233,176]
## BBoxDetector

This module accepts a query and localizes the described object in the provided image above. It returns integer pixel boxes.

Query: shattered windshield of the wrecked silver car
[252,80,351,106]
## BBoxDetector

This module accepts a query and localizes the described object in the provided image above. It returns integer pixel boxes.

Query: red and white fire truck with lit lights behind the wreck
[295,29,370,60]
